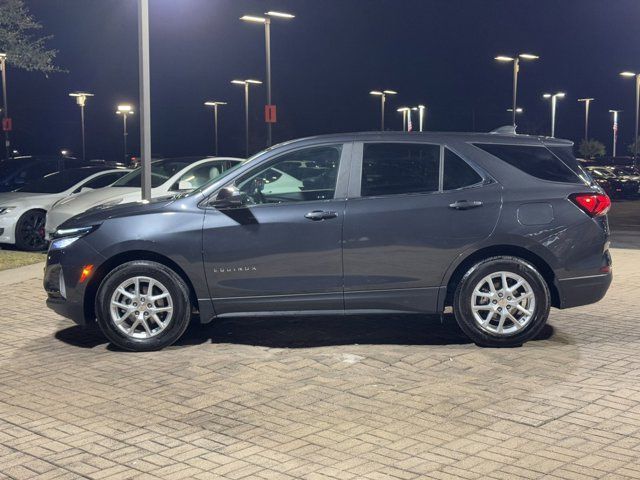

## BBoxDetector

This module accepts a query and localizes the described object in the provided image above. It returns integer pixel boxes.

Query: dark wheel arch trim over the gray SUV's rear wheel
[442,244,560,307]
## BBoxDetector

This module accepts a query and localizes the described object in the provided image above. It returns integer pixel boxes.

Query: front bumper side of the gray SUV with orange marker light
[43,238,104,325]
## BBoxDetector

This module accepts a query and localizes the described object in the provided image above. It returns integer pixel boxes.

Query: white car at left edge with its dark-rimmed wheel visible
[0,167,131,251]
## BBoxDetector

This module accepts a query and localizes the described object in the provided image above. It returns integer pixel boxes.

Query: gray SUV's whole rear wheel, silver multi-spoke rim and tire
[453,256,550,347]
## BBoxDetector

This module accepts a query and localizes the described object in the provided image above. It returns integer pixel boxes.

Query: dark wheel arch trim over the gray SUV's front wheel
[83,250,200,322]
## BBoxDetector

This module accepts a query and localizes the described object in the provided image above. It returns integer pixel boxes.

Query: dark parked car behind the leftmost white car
[0,156,89,192]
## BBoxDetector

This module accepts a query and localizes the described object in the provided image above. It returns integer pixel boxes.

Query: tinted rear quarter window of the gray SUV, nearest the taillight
[474,143,584,183]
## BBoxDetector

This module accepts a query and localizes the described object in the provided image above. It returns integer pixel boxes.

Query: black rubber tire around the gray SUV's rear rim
[453,256,551,347]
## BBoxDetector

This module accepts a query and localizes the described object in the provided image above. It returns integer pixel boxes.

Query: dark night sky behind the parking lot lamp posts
[8,0,640,159]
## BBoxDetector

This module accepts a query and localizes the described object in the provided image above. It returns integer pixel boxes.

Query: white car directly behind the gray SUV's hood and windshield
[45,157,243,238]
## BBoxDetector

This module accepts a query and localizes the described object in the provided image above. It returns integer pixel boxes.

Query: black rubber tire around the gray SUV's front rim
[95,260,191,352]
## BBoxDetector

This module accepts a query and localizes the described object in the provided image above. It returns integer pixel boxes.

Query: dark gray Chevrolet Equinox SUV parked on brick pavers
[44,133,611,350]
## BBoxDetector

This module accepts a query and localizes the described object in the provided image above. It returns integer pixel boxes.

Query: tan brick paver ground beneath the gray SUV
[0,250,640,480]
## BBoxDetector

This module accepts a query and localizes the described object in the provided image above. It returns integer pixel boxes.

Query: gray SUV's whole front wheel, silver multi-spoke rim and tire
[96,260,191,351]
